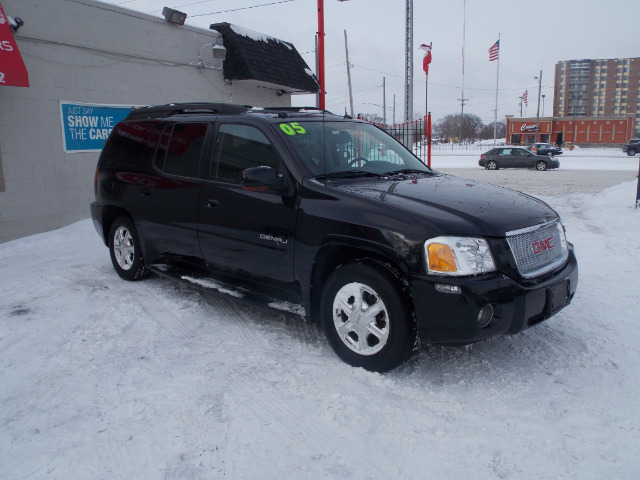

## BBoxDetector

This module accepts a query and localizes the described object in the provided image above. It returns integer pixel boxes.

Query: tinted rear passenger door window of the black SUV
[154,123,207,178]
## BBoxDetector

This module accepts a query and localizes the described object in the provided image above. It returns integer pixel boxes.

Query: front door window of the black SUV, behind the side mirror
[208,124,280,183]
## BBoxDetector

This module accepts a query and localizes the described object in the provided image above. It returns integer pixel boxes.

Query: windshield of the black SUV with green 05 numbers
[279,121,431,176]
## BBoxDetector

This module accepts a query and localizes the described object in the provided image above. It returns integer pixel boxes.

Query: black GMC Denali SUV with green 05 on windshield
[91,104,578,371]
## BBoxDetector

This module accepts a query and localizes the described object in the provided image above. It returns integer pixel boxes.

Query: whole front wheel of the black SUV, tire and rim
[321,263,418,372]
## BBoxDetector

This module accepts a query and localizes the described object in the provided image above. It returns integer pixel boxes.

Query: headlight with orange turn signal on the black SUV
[424,237,496,276]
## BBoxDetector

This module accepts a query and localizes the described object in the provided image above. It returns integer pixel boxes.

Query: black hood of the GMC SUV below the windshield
[328,172,558,237]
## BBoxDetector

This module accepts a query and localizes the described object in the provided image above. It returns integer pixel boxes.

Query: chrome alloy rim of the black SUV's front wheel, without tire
[333,283,389,355]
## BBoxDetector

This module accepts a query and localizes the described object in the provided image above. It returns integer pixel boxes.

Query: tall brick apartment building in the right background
[553,57,640,135]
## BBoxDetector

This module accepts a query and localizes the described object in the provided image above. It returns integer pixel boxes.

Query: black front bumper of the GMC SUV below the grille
[410,248,578,344]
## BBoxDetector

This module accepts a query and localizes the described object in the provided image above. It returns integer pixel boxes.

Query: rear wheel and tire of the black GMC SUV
[109,216,151,281]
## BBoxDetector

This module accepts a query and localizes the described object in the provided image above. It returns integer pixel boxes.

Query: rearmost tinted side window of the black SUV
[100,123,158,172]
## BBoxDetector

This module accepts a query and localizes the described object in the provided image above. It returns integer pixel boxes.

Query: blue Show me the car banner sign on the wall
[60,102,133,153]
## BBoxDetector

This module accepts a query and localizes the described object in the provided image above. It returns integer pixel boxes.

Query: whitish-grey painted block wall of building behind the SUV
[0,0,291,243]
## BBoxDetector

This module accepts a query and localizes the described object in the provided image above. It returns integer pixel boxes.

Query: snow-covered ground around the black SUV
[0,152,640,480]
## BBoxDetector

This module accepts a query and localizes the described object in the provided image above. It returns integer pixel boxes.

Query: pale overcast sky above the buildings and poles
[107,0,640,123]
